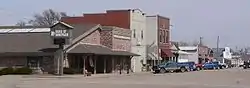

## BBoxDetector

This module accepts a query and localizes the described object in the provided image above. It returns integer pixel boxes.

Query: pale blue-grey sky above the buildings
[0,0,250,48]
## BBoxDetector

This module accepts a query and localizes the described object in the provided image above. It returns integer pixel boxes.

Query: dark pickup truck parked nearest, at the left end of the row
[152,62,189,73]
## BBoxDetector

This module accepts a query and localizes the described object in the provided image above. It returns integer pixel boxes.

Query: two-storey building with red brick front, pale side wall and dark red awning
[146,15,174,65]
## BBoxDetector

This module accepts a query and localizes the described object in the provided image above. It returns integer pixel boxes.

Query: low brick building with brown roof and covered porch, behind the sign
[0,24,137,74]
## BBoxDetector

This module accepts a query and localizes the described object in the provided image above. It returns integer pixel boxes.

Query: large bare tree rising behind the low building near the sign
[29,9,67,26]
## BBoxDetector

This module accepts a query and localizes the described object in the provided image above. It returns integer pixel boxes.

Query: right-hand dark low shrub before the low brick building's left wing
[14,67,32,75]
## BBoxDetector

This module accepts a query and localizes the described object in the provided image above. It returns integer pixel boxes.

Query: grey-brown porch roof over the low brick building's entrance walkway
[68,44,139,56]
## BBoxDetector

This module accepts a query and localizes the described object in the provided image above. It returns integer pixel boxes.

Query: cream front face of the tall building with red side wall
[130,9,146,72]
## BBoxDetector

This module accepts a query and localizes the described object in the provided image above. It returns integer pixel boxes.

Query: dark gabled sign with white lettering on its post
[50,22,73,75]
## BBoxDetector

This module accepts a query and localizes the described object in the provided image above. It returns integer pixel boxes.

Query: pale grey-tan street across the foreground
[0,68,250,88]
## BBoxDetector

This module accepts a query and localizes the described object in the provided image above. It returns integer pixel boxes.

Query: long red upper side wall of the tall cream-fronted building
[62,10,130,29]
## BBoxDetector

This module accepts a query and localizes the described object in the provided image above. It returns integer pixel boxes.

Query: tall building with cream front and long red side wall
[62,9,146,72]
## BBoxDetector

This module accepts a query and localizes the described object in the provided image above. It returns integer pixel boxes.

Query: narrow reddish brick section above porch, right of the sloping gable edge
[100,30,113,49]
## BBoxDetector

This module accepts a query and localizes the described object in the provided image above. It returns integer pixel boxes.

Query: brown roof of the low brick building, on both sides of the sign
[0,24,97,53]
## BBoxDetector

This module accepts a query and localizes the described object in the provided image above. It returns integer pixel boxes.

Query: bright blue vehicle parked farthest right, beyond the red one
[202,62,220,69]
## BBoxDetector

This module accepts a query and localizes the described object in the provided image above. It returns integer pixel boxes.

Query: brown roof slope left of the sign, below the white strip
[0,33,57,53]
